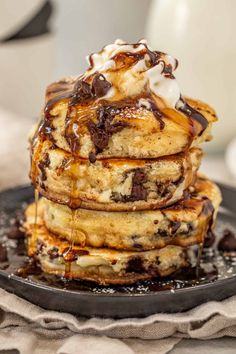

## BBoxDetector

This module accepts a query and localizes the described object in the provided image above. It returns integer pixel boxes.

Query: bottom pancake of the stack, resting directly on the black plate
[27,221,188,285]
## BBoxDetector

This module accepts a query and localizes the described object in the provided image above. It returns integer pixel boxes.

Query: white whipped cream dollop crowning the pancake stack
[83,40,180,108]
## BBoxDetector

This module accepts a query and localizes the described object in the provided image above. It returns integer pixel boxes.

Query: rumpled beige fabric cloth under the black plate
[0,289,236,354]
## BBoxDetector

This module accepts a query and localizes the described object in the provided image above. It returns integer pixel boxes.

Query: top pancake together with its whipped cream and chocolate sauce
[31,43,216,160]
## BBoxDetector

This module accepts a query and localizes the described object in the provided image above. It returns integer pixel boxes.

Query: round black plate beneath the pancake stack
[0,185,236,318]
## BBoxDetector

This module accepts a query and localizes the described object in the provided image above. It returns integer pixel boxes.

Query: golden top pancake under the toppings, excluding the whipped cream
[32,91,216,159]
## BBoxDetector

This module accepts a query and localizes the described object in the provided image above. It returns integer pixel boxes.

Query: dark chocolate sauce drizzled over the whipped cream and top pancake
[39,43,208,158]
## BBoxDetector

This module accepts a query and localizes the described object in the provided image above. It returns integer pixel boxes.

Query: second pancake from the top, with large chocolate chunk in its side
[31,140,202,211]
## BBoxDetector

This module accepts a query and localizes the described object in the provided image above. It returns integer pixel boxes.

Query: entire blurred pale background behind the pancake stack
[0,0,236,184]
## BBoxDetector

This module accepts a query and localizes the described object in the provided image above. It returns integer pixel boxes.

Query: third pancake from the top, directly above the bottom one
[26,177,221,251]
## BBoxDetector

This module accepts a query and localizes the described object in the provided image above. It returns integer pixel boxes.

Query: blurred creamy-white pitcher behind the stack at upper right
[146,0,236,151]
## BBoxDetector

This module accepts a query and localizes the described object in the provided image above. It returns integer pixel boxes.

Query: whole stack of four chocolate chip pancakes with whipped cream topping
[25,41,221,284]
